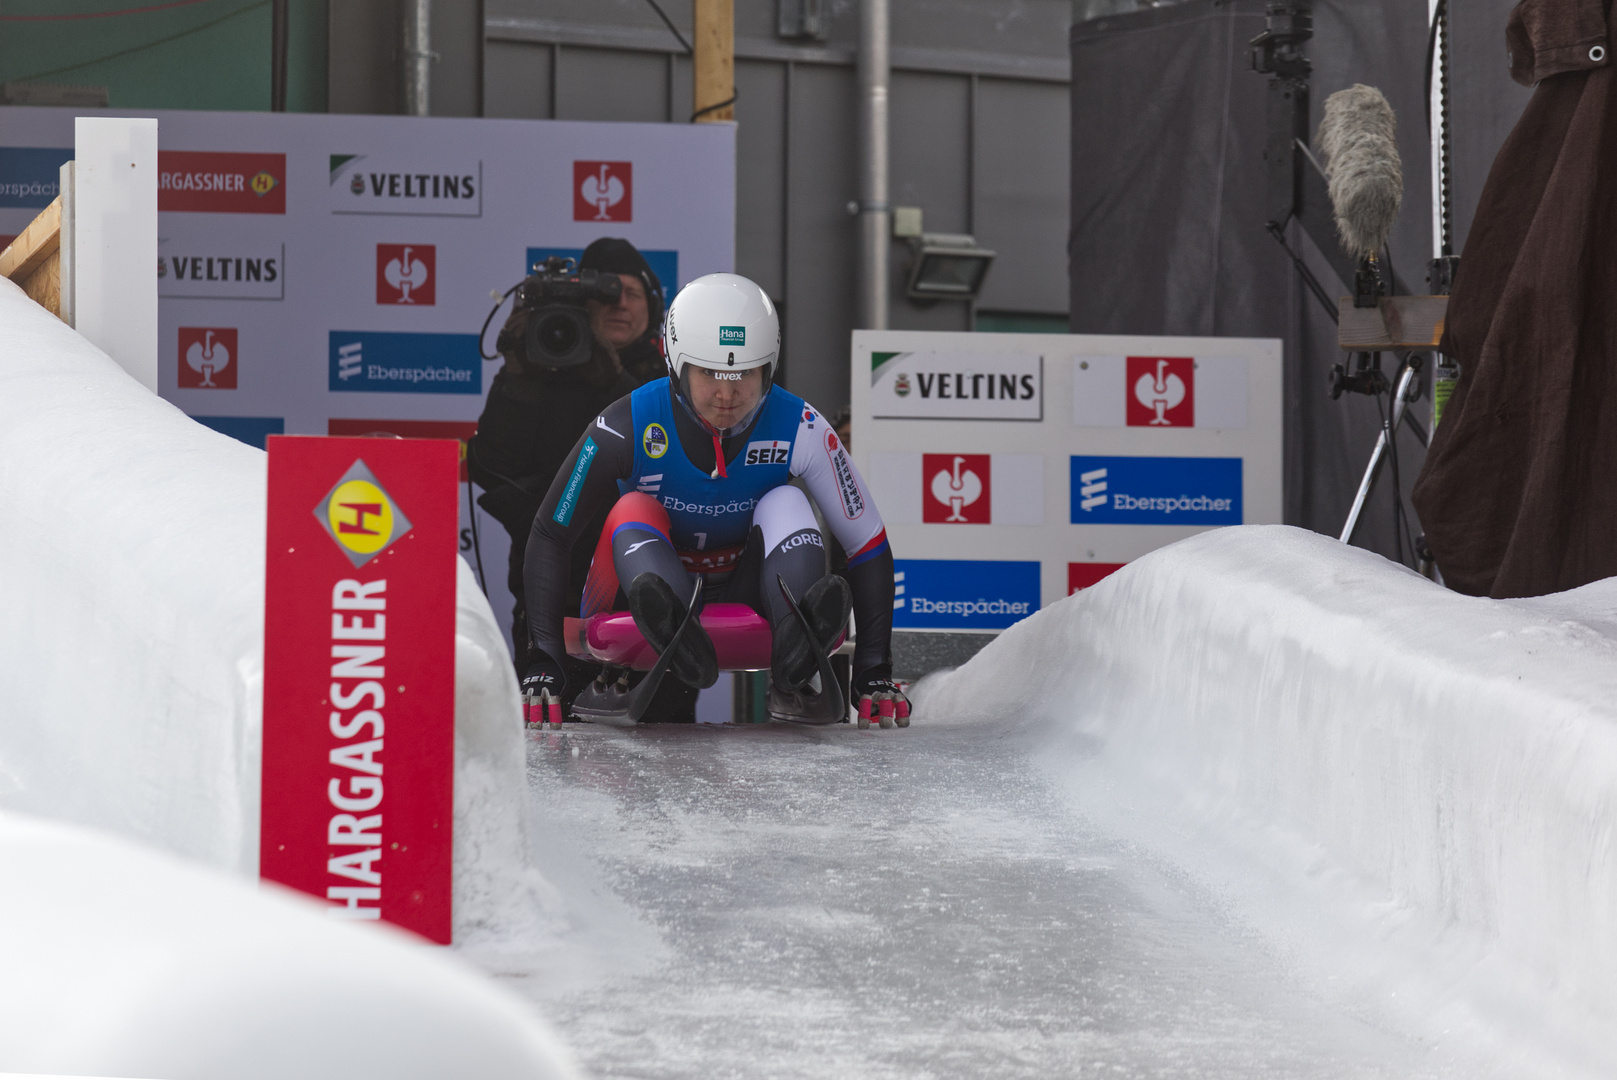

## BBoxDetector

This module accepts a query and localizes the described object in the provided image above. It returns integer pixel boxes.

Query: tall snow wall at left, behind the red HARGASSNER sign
[0,280,548,944]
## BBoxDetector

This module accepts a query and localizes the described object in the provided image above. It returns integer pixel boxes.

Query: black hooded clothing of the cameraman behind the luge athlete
[467,238,665,686]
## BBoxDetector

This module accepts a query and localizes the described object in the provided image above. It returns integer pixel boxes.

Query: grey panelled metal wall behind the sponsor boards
[331,0,1070,411]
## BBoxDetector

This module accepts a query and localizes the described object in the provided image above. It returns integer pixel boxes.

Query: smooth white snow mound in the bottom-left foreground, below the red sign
[0,813,577,1080]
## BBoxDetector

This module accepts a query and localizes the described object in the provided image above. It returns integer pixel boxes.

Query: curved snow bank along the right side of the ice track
[917,525,1617,1075]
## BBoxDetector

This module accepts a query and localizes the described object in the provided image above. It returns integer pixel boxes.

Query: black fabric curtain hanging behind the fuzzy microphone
[1067,0,1429,556]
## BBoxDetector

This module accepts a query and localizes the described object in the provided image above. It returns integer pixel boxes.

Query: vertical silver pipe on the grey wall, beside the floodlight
[857,0,893,330]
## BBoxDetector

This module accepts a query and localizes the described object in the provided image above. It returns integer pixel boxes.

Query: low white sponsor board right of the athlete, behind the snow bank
[852,330,1281,634]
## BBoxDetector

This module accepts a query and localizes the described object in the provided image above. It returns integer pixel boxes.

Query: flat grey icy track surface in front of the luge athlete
[508,724,1450,1078]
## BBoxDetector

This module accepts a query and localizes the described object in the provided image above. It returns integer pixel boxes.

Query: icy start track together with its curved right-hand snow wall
[508,527,1617,1078]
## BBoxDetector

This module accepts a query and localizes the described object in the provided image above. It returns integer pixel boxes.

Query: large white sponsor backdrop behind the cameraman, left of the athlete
[0,107,736,653]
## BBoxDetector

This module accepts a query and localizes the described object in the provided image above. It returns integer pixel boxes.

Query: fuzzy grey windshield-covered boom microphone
[1318,84,1404,259]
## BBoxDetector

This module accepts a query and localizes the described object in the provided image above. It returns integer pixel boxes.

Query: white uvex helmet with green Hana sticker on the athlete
[663,273,781,417]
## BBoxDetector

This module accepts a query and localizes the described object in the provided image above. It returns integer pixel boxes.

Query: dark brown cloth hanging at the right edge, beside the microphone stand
[1413,0,1617,597]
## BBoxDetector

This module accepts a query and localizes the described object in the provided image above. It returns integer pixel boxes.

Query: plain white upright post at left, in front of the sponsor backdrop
[70,116,157,394]
